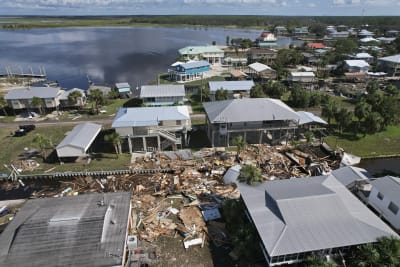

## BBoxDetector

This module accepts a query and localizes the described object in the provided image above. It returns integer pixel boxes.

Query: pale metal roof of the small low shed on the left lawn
[56,122,102,157]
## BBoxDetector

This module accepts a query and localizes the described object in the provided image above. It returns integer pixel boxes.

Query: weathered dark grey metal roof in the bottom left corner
[0,192,131,267]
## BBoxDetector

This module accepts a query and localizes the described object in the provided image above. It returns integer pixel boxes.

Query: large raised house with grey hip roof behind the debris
[203,98,300,146]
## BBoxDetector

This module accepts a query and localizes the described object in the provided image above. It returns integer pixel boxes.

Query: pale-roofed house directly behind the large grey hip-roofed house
[208,80,254,101]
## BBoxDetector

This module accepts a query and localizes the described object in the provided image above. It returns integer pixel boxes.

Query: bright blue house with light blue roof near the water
[168,61,210,82]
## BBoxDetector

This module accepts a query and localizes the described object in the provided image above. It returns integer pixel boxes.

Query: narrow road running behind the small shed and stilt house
[0,114,206,128]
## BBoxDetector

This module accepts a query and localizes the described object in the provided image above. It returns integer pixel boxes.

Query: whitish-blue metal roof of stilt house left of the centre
[112,106,190,128]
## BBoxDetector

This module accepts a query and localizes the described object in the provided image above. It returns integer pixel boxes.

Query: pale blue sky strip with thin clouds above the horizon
[0,0,400,16]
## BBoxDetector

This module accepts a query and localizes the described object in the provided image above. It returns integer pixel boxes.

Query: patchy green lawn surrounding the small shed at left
[0,126,130,176]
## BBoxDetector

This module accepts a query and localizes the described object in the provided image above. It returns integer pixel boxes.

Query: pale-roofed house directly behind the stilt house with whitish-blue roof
[140,84,185,106]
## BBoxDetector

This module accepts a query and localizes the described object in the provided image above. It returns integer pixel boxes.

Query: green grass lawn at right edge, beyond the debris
[325,126,400,157]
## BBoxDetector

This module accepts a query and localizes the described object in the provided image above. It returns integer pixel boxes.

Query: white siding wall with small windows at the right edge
[368,187,400,230]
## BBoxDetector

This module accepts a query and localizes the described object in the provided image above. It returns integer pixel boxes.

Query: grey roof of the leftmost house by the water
[4,87,61,100]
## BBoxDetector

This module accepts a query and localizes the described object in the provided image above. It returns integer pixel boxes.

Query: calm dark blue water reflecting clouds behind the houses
[0,27,291,89]
